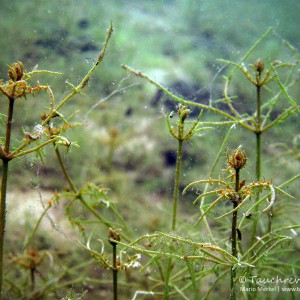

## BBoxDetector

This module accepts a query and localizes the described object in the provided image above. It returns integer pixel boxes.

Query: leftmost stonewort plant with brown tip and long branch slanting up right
[0,24,113,294]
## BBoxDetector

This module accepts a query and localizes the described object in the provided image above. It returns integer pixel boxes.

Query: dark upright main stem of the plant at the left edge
[0,98,15,298]
